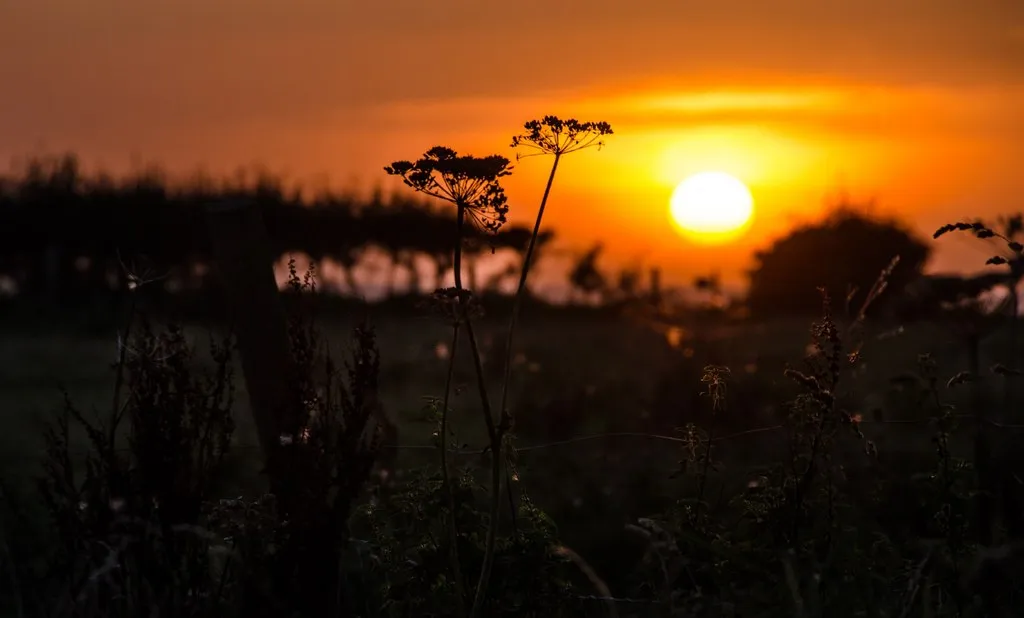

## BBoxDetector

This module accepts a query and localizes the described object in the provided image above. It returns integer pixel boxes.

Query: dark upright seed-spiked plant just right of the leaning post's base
[254,261,385,615]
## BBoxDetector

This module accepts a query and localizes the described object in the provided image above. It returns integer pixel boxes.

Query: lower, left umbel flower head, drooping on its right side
[384,146,512,233]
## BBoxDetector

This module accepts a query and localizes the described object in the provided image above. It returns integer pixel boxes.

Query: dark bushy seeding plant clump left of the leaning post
[34,321,234,616]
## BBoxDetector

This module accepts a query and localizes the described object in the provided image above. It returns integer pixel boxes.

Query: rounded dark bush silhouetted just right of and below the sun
[746,207,930,316]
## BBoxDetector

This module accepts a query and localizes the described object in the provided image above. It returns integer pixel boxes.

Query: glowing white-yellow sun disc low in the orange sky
[669,172,754,242]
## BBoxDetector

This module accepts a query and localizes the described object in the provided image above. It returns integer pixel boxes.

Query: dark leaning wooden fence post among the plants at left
[207,201,292,474]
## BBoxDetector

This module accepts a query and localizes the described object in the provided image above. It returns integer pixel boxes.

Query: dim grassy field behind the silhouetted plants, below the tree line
[0,300,1019,613]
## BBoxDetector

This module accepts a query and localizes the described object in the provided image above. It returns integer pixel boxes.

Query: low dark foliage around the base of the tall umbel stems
[344,470,583,618]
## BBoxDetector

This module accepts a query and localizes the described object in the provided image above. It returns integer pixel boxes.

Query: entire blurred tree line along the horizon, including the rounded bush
[0,155,1011,315]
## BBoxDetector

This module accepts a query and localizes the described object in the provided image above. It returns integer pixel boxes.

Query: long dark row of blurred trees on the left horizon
[0,155,551,301]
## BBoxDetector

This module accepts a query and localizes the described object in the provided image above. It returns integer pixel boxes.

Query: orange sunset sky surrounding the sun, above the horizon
[0,0,1024,290]
